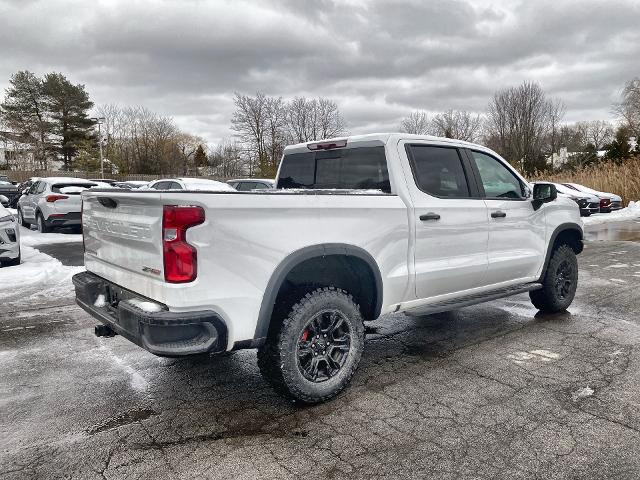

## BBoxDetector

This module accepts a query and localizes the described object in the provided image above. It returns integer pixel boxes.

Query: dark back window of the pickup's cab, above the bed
[277,146,391,192]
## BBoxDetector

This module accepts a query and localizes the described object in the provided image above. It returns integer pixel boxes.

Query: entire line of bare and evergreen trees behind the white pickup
[0,67,640,178]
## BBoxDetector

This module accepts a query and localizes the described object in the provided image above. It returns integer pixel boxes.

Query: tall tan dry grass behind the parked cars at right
[529,157,640,206]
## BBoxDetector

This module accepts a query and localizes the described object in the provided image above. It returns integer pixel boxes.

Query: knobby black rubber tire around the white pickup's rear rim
[258,287,364,404]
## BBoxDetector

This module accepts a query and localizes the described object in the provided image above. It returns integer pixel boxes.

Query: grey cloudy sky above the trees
[0,0,640,143]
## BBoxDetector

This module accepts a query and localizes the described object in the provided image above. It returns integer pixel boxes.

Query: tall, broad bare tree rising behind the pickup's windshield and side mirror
[487,82,564,173]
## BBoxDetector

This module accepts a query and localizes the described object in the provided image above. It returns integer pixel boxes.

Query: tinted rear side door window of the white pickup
[407,145,471,198]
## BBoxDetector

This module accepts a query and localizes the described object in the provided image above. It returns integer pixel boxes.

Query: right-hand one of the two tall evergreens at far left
[42,73,93,170]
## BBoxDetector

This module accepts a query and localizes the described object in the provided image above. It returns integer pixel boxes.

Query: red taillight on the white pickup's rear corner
[162,205,204,283]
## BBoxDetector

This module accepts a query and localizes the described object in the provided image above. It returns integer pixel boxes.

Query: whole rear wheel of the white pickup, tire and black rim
[258,287,364,404]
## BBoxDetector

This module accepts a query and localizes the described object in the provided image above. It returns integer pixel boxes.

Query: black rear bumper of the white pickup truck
[73,272,227,357]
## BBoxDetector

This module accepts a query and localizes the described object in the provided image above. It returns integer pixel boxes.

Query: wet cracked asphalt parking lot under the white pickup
[0,222,640,479]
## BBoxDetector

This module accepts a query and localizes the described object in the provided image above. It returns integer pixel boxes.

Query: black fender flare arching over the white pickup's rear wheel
[249,243,382,347]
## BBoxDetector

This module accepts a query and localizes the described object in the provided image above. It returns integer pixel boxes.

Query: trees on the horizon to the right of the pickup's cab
[400,78,640,174]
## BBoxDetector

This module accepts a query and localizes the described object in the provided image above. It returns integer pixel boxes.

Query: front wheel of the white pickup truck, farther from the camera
[529,244,578,313]
